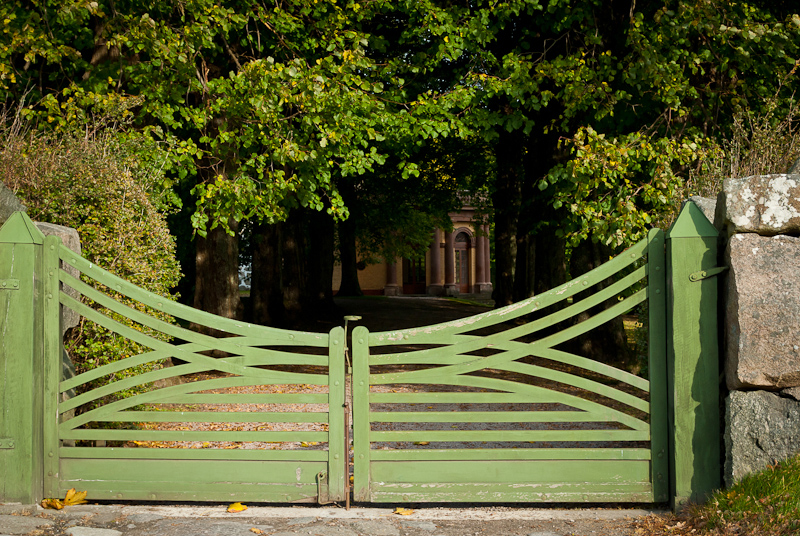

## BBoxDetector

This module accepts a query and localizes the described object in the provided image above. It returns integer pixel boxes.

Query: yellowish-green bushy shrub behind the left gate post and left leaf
[0,112,180,406]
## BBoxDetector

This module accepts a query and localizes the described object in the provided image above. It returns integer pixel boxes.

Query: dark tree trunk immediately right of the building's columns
[492,130,524,307]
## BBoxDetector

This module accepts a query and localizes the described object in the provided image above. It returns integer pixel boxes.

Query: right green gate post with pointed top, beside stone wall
[667,203,721,508]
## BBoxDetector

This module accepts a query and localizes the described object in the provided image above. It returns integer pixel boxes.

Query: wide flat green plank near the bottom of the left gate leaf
[61,456,327,490]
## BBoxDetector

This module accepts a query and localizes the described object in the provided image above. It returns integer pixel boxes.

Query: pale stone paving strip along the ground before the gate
[0,504,660,536]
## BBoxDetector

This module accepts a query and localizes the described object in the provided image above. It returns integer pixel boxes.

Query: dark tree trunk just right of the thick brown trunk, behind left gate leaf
[250,223,286,327]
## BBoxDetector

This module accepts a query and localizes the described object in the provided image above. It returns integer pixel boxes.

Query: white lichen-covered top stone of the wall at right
[721,174,800,236]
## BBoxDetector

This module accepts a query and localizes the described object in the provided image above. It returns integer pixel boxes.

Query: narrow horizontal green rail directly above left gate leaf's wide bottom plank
[59,447,328,464]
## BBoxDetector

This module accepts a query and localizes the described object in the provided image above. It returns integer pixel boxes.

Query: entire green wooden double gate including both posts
[0,205,719,503]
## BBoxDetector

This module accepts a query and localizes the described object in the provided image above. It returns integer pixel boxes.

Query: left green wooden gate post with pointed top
[0,212,44,504]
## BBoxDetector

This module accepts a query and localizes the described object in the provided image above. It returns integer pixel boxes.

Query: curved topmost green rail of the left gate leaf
[59,246,328,347]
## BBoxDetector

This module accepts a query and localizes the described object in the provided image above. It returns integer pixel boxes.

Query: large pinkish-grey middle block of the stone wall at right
[724,233,800,391]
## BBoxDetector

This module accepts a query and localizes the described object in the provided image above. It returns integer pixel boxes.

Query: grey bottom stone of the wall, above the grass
[725,391,800,486]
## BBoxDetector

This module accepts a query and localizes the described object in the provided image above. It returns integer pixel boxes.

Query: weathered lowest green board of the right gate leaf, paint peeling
[370,482,653,504]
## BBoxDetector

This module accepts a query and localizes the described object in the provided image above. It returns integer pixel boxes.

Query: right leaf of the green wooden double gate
[353,230,668,502]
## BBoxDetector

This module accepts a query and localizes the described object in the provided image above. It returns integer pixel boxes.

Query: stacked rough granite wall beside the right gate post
[715,174,800,485]
